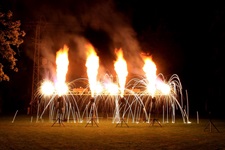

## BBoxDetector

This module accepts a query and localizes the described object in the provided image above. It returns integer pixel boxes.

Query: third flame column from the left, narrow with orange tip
[114,49,128,97]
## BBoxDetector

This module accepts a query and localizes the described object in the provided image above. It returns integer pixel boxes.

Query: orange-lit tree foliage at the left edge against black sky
[0,11,25,81]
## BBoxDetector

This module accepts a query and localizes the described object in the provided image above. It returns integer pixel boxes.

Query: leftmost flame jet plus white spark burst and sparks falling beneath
[37,45,80,125]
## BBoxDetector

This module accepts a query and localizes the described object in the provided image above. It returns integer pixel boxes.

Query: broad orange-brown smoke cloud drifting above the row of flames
[15,0,146,80]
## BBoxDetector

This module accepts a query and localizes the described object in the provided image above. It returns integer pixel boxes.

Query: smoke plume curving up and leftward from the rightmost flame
[82,1,143,74]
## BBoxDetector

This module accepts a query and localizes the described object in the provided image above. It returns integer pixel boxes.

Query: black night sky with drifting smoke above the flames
[0,0,225,117]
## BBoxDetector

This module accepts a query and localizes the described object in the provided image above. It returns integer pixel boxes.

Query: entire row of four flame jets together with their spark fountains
[33,44,190,127]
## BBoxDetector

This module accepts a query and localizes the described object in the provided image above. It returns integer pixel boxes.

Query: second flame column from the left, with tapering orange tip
[86,44,99,97]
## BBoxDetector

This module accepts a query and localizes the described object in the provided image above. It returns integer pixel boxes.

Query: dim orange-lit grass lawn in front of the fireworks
[0,115,225,150]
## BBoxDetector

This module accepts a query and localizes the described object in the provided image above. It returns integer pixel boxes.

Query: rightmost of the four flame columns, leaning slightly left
[143,57,157,97]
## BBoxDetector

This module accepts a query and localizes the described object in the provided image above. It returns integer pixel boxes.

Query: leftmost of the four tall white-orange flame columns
[55,45,69,95]
